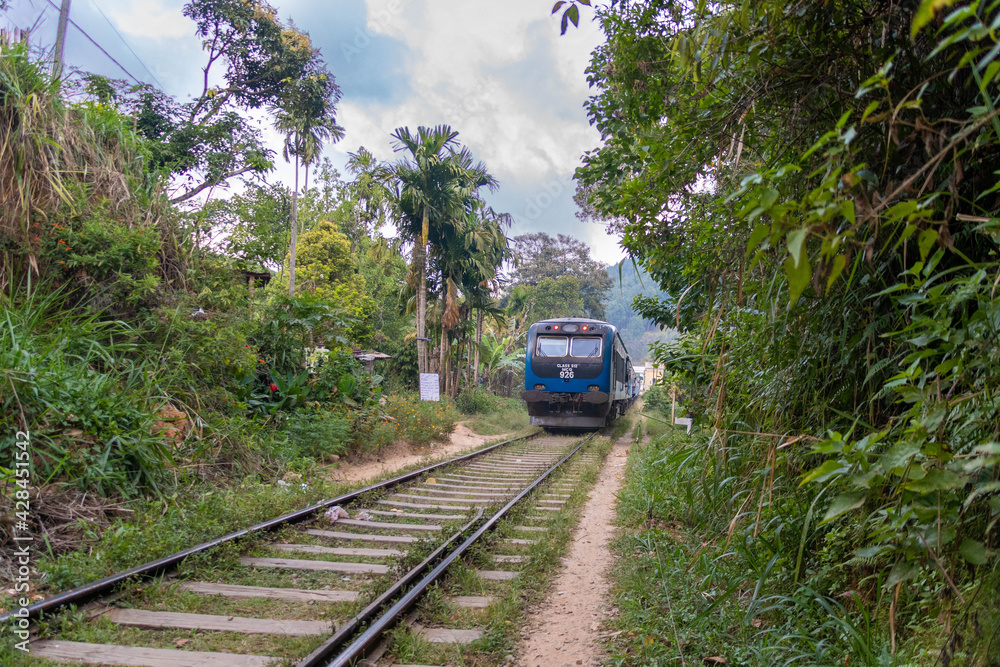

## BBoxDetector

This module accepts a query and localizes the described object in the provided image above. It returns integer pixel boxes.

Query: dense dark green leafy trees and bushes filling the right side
[578,0,1000,664]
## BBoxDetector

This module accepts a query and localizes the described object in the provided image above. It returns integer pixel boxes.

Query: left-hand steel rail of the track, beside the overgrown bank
[0,431,541,623]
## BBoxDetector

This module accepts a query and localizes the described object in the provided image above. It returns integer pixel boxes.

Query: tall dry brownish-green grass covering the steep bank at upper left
[0,36,175,288]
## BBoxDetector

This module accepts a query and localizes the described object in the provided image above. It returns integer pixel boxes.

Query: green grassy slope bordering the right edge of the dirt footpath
[610,422,998,666]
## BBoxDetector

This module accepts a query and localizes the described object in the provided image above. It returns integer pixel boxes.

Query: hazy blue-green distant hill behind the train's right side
[604,261,677,364]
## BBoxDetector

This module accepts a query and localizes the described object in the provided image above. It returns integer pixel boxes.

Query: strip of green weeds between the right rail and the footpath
[378,434,630,665]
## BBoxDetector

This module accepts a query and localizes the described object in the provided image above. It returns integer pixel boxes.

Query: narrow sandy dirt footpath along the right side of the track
[517,435,630,667]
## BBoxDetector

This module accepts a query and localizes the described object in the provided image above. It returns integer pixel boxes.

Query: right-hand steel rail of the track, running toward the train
[314,432,597,667]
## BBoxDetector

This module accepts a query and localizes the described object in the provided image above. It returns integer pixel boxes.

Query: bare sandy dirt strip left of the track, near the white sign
[330,422,510,482]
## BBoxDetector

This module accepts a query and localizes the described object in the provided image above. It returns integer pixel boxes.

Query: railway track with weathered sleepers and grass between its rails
[7,435,593,667]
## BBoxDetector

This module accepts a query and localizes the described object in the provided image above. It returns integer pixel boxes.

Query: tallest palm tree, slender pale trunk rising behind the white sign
[392,125,496,373]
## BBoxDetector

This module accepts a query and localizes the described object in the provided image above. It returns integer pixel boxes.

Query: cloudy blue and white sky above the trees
[5,0,623,263]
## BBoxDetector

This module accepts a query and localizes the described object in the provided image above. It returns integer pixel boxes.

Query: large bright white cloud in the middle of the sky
[332,0,600,184]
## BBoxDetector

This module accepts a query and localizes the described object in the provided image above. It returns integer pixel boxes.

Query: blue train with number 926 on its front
[521,317,641,428]
